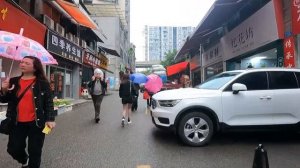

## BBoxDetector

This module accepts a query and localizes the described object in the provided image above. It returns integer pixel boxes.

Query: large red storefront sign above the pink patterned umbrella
[0,1,46,45]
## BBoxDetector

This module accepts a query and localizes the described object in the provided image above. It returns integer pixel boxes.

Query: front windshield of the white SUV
[196,72,241,90]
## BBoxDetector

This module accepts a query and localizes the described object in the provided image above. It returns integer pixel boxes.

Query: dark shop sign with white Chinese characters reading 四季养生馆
[47,30,83,63]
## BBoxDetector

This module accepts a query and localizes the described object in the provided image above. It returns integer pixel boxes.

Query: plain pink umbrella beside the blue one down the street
[145,74,163,93]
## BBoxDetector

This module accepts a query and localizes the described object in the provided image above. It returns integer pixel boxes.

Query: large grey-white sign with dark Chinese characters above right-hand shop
[221,1,279,60]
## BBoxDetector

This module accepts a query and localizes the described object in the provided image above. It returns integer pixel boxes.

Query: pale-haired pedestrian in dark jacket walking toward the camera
[88,68,106,123]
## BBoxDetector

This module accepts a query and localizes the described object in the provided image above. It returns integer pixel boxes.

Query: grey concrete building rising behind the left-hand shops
[85,0,133,89]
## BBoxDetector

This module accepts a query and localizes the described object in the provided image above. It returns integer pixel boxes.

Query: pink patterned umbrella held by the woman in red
[0,29,58,76]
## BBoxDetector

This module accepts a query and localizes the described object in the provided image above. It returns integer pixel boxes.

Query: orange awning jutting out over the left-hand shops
[56,0,97,29]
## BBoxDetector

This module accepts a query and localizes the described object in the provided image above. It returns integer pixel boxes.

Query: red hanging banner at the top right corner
[291,0,300,35]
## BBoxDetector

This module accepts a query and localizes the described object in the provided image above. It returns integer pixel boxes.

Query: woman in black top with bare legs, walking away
[119,74,136,127]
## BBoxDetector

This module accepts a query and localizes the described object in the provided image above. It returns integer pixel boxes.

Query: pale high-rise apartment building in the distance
[144,26,194,61]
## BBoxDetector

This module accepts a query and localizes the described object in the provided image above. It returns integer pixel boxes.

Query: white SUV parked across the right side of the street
[151,68,300,146]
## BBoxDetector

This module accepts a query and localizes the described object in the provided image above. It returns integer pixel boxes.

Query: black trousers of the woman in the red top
[7,121,45,168]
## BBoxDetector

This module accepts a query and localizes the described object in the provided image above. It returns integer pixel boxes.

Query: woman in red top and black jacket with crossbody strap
[0,56,55,168]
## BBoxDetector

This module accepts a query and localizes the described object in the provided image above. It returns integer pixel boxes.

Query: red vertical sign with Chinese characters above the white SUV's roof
[284,36,295,68]
